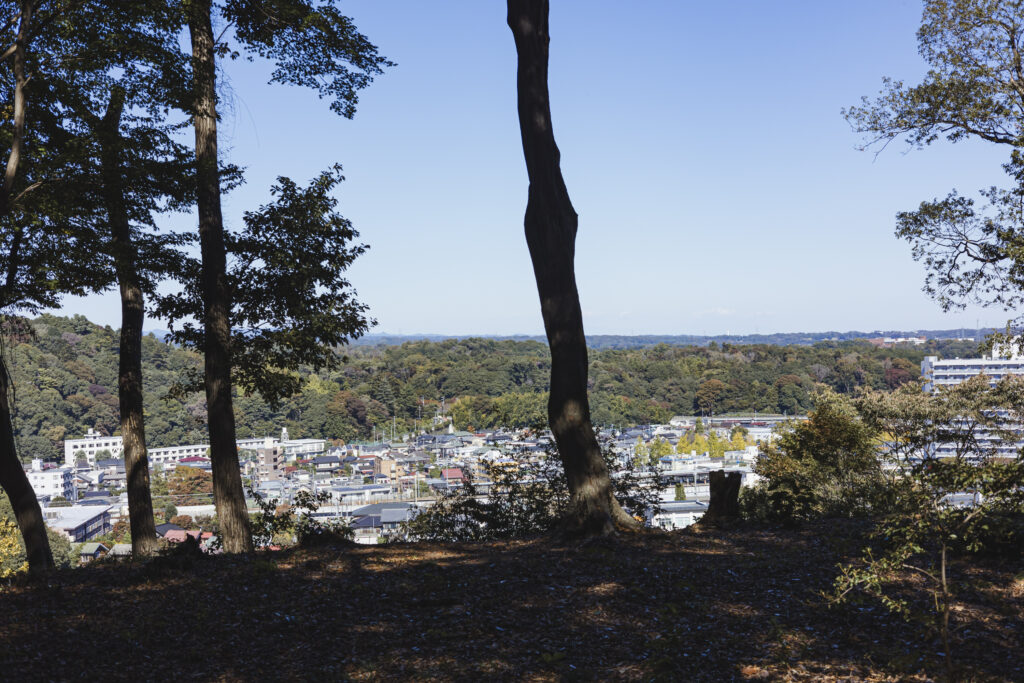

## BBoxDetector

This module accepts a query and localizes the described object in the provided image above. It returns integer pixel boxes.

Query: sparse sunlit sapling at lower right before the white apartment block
[834,376,1024,675]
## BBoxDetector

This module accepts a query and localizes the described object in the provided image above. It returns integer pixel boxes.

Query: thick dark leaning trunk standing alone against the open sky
[508,0,638,535]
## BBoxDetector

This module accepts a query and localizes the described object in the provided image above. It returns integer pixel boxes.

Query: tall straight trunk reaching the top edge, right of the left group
[188,0,252,553]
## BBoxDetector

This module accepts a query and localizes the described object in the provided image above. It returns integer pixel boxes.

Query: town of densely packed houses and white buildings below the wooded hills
[18,416,782,561]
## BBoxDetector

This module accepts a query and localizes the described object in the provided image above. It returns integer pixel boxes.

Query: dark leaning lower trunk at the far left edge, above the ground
[0,353,53,573]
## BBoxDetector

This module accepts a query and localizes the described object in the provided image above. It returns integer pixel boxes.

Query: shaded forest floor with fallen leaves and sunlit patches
[0,524,1024,681]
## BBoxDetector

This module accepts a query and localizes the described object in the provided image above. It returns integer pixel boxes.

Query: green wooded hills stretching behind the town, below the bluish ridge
[9,315,975,458]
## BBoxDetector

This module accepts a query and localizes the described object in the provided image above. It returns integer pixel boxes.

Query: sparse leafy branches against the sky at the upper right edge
[844,0,1024,319]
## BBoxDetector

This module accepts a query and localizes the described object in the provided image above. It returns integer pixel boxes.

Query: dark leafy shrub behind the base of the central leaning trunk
[400,450,665,543]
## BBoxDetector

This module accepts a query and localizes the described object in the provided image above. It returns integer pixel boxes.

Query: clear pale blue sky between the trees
[63,0,1008,334]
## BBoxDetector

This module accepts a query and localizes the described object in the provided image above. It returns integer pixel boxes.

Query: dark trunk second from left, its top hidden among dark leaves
[97,88,158,557]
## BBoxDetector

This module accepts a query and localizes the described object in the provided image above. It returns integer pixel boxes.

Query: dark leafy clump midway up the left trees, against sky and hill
[157,166,373,408]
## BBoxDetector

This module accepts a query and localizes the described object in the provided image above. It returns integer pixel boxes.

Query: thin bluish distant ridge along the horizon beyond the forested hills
[147,328,995,349]
